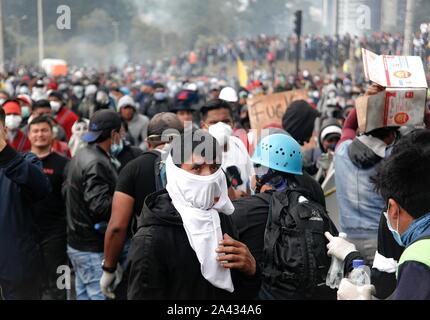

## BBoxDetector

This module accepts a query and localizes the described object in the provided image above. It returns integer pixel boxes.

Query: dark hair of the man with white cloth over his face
[171,129,222,167]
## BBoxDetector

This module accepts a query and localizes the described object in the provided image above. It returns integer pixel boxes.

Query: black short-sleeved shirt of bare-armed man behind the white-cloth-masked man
[115,152,158,217]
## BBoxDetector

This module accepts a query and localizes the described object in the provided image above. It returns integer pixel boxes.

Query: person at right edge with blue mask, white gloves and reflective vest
[327,130,430,300]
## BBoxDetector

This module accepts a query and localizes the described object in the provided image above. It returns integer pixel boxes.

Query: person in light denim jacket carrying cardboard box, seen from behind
[335,89,398,264]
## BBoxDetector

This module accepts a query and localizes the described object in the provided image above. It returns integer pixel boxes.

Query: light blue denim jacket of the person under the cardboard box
[335,140,389,239]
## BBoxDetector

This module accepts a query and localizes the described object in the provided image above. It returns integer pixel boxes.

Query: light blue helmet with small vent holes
[251,134,303,175]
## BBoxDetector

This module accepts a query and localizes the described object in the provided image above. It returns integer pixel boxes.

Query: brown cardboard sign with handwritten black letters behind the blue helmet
[248,90,308,130]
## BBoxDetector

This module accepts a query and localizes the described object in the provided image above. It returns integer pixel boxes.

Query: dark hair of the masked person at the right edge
[372,129,430,218]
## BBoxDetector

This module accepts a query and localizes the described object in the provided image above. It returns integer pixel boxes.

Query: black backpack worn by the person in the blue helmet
[262,187,338,300]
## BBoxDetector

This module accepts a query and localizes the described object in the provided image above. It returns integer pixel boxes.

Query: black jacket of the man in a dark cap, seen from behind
[64,144,117,252]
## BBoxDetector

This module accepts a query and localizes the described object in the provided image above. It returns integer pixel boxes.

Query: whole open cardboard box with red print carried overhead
[356,49,427,132]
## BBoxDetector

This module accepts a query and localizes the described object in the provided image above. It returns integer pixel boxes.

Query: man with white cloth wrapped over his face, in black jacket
[128,130,260,300]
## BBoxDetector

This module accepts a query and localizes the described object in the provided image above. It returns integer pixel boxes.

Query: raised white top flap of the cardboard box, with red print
[362,49,427,88]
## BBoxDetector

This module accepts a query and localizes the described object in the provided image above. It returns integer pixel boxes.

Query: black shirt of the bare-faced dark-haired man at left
[32,152,69,236]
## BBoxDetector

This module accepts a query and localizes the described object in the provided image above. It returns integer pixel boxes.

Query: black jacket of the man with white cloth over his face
[128,190,260,300]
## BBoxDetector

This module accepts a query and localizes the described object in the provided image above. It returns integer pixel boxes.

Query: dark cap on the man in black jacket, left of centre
[82,110,121,143]
